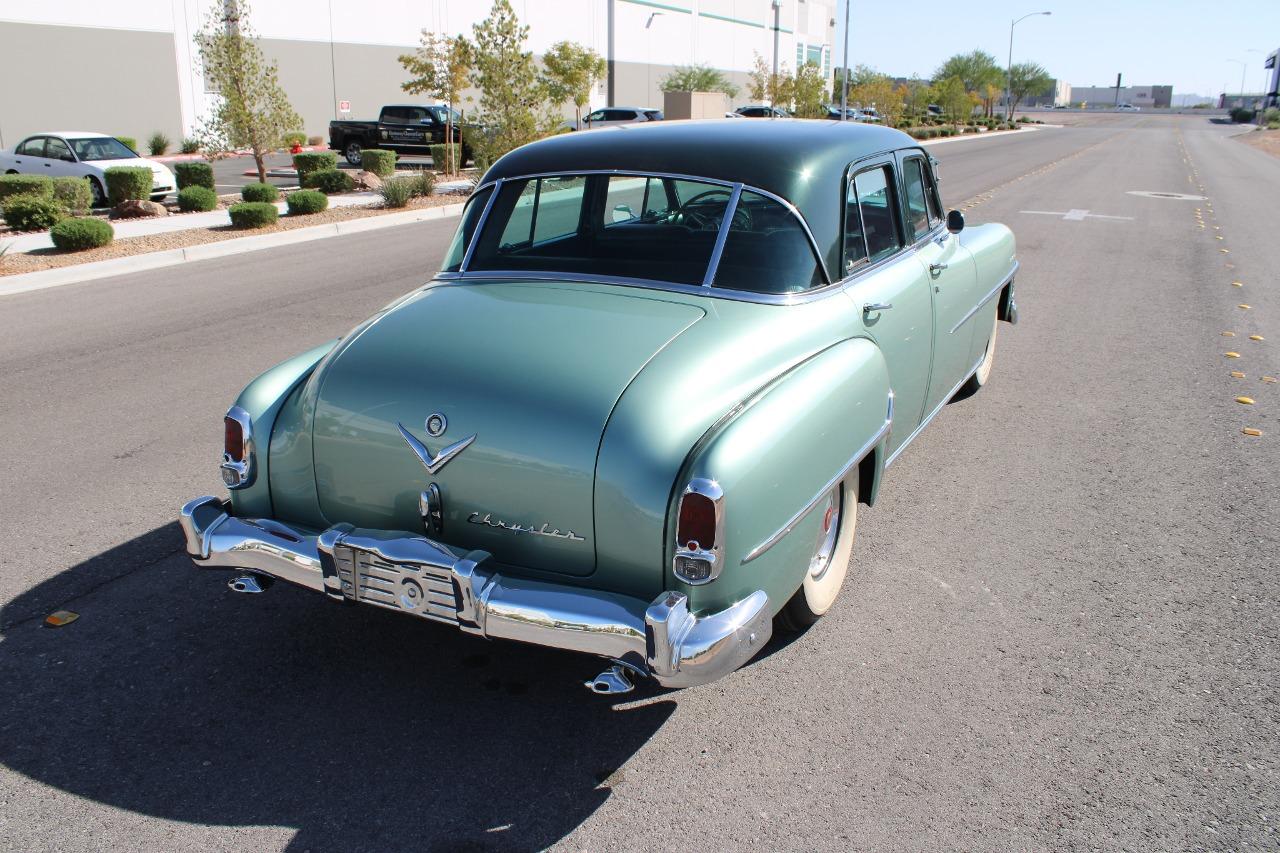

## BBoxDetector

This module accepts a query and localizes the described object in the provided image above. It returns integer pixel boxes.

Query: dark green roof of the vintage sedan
[481,118,919,270]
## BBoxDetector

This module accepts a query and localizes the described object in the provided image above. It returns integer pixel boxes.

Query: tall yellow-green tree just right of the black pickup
[471,0,558,164]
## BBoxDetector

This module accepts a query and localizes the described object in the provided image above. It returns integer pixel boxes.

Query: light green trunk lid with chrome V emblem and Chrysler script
[312,282,703,575]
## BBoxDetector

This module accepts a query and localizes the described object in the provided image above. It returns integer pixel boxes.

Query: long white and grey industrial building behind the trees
[0,0,837,146]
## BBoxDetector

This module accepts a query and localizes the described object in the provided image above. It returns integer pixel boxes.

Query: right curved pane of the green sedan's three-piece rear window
[713,190,826,293]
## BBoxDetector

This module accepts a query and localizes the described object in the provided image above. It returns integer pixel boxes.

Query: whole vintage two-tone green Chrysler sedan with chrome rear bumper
[182,119,1018,693]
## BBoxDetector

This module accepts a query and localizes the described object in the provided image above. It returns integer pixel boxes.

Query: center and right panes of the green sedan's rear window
[463,174,822,293]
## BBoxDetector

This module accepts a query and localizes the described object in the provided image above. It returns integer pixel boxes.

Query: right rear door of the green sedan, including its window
[842,155,933,455]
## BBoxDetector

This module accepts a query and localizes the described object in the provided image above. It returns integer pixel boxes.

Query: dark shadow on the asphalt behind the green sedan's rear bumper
[0,525,675,850]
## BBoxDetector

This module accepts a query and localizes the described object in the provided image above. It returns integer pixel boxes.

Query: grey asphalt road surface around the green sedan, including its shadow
[0,115,1280,852]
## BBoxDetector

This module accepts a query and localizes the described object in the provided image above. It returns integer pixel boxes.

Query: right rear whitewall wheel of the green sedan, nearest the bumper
[778,479,858,631]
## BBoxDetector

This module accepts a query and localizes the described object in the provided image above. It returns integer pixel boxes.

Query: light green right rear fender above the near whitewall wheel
[666,338,892,612]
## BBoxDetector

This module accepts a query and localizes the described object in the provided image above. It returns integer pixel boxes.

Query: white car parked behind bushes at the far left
[0,131,175,207]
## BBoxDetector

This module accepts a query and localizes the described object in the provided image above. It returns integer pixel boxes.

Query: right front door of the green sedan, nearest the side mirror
[899,156,978,412]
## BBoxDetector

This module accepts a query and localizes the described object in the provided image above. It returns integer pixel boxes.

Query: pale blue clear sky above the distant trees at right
[832,0,1280,96]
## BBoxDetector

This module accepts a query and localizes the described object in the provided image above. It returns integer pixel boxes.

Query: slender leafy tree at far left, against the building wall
[196,0,302,183]
